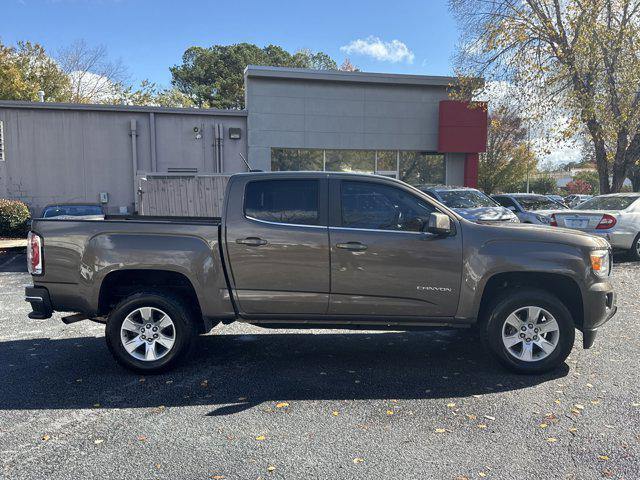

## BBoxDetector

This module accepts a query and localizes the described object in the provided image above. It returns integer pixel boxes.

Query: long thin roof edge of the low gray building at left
[0,100,247,117]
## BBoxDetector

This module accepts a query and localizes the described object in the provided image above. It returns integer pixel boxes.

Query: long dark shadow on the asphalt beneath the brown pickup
[0,330,568,416]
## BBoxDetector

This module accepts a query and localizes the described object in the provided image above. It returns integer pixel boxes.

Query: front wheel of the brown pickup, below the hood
[483,289,575,374]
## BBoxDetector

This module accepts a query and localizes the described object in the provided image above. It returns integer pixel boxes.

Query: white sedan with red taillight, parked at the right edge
[552,193,640,260]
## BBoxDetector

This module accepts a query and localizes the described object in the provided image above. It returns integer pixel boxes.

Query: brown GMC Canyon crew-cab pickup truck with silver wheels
[26,172,616,373]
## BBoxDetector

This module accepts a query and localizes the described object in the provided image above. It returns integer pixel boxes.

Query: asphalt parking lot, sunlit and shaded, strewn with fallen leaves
[0,255,640,480]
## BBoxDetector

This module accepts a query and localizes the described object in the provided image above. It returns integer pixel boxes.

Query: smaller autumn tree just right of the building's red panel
[478,106,536,194]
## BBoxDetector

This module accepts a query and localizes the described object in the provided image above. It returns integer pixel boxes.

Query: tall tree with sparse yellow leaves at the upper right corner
[450,0,640,193]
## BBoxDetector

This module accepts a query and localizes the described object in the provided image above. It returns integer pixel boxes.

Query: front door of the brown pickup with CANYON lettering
[329,178,462,319]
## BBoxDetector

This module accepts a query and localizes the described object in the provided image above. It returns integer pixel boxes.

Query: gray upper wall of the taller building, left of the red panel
[246,73,448,170]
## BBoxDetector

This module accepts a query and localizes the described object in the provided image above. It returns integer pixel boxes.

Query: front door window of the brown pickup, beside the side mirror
[341,181,435,232]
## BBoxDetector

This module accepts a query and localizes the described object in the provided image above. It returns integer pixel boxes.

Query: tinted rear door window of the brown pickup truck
[244,179,319,225]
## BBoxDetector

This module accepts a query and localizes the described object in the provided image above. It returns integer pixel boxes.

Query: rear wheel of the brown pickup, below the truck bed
[105,292,197,374]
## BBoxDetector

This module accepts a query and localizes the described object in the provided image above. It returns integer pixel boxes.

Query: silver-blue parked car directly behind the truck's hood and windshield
[420,186,518,223]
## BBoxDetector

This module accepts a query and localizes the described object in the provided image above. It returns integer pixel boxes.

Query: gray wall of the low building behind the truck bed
[0,102,247,212]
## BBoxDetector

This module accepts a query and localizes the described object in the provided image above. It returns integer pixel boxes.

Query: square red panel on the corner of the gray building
[438,100,487,153]
